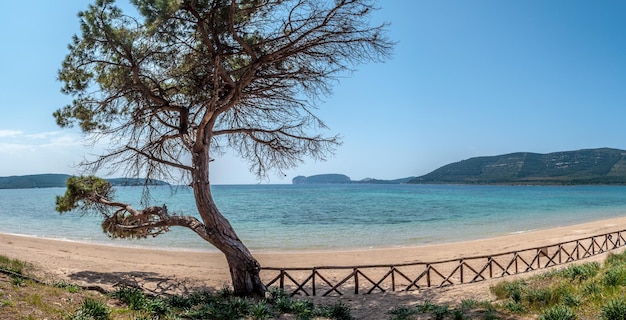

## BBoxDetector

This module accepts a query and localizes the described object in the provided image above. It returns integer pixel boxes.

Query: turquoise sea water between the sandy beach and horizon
[0,185,626,251]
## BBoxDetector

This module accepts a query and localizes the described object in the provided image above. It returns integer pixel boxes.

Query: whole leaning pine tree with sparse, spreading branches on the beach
[54,0,394,297]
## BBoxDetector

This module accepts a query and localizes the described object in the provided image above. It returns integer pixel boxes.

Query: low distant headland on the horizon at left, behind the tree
[0,173,168,189]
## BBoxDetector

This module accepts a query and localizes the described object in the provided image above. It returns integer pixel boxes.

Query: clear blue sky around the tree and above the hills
[0,0,626,184]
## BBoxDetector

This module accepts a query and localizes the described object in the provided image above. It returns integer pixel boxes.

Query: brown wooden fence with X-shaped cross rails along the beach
[261,230,626,296]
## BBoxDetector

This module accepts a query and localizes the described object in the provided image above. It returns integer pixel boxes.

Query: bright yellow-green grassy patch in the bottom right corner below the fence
[491,253,626,319]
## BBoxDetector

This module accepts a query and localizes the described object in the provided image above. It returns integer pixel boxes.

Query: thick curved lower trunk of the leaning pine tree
[192,149,266,296]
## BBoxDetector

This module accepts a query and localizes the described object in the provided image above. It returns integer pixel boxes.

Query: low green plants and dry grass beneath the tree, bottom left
[0,264,354,320]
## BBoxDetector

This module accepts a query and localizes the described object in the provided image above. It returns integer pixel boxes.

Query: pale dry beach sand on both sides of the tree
[0,217,626,319]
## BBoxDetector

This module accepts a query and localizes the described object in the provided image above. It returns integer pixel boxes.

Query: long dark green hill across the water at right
[409,148,626,185]
